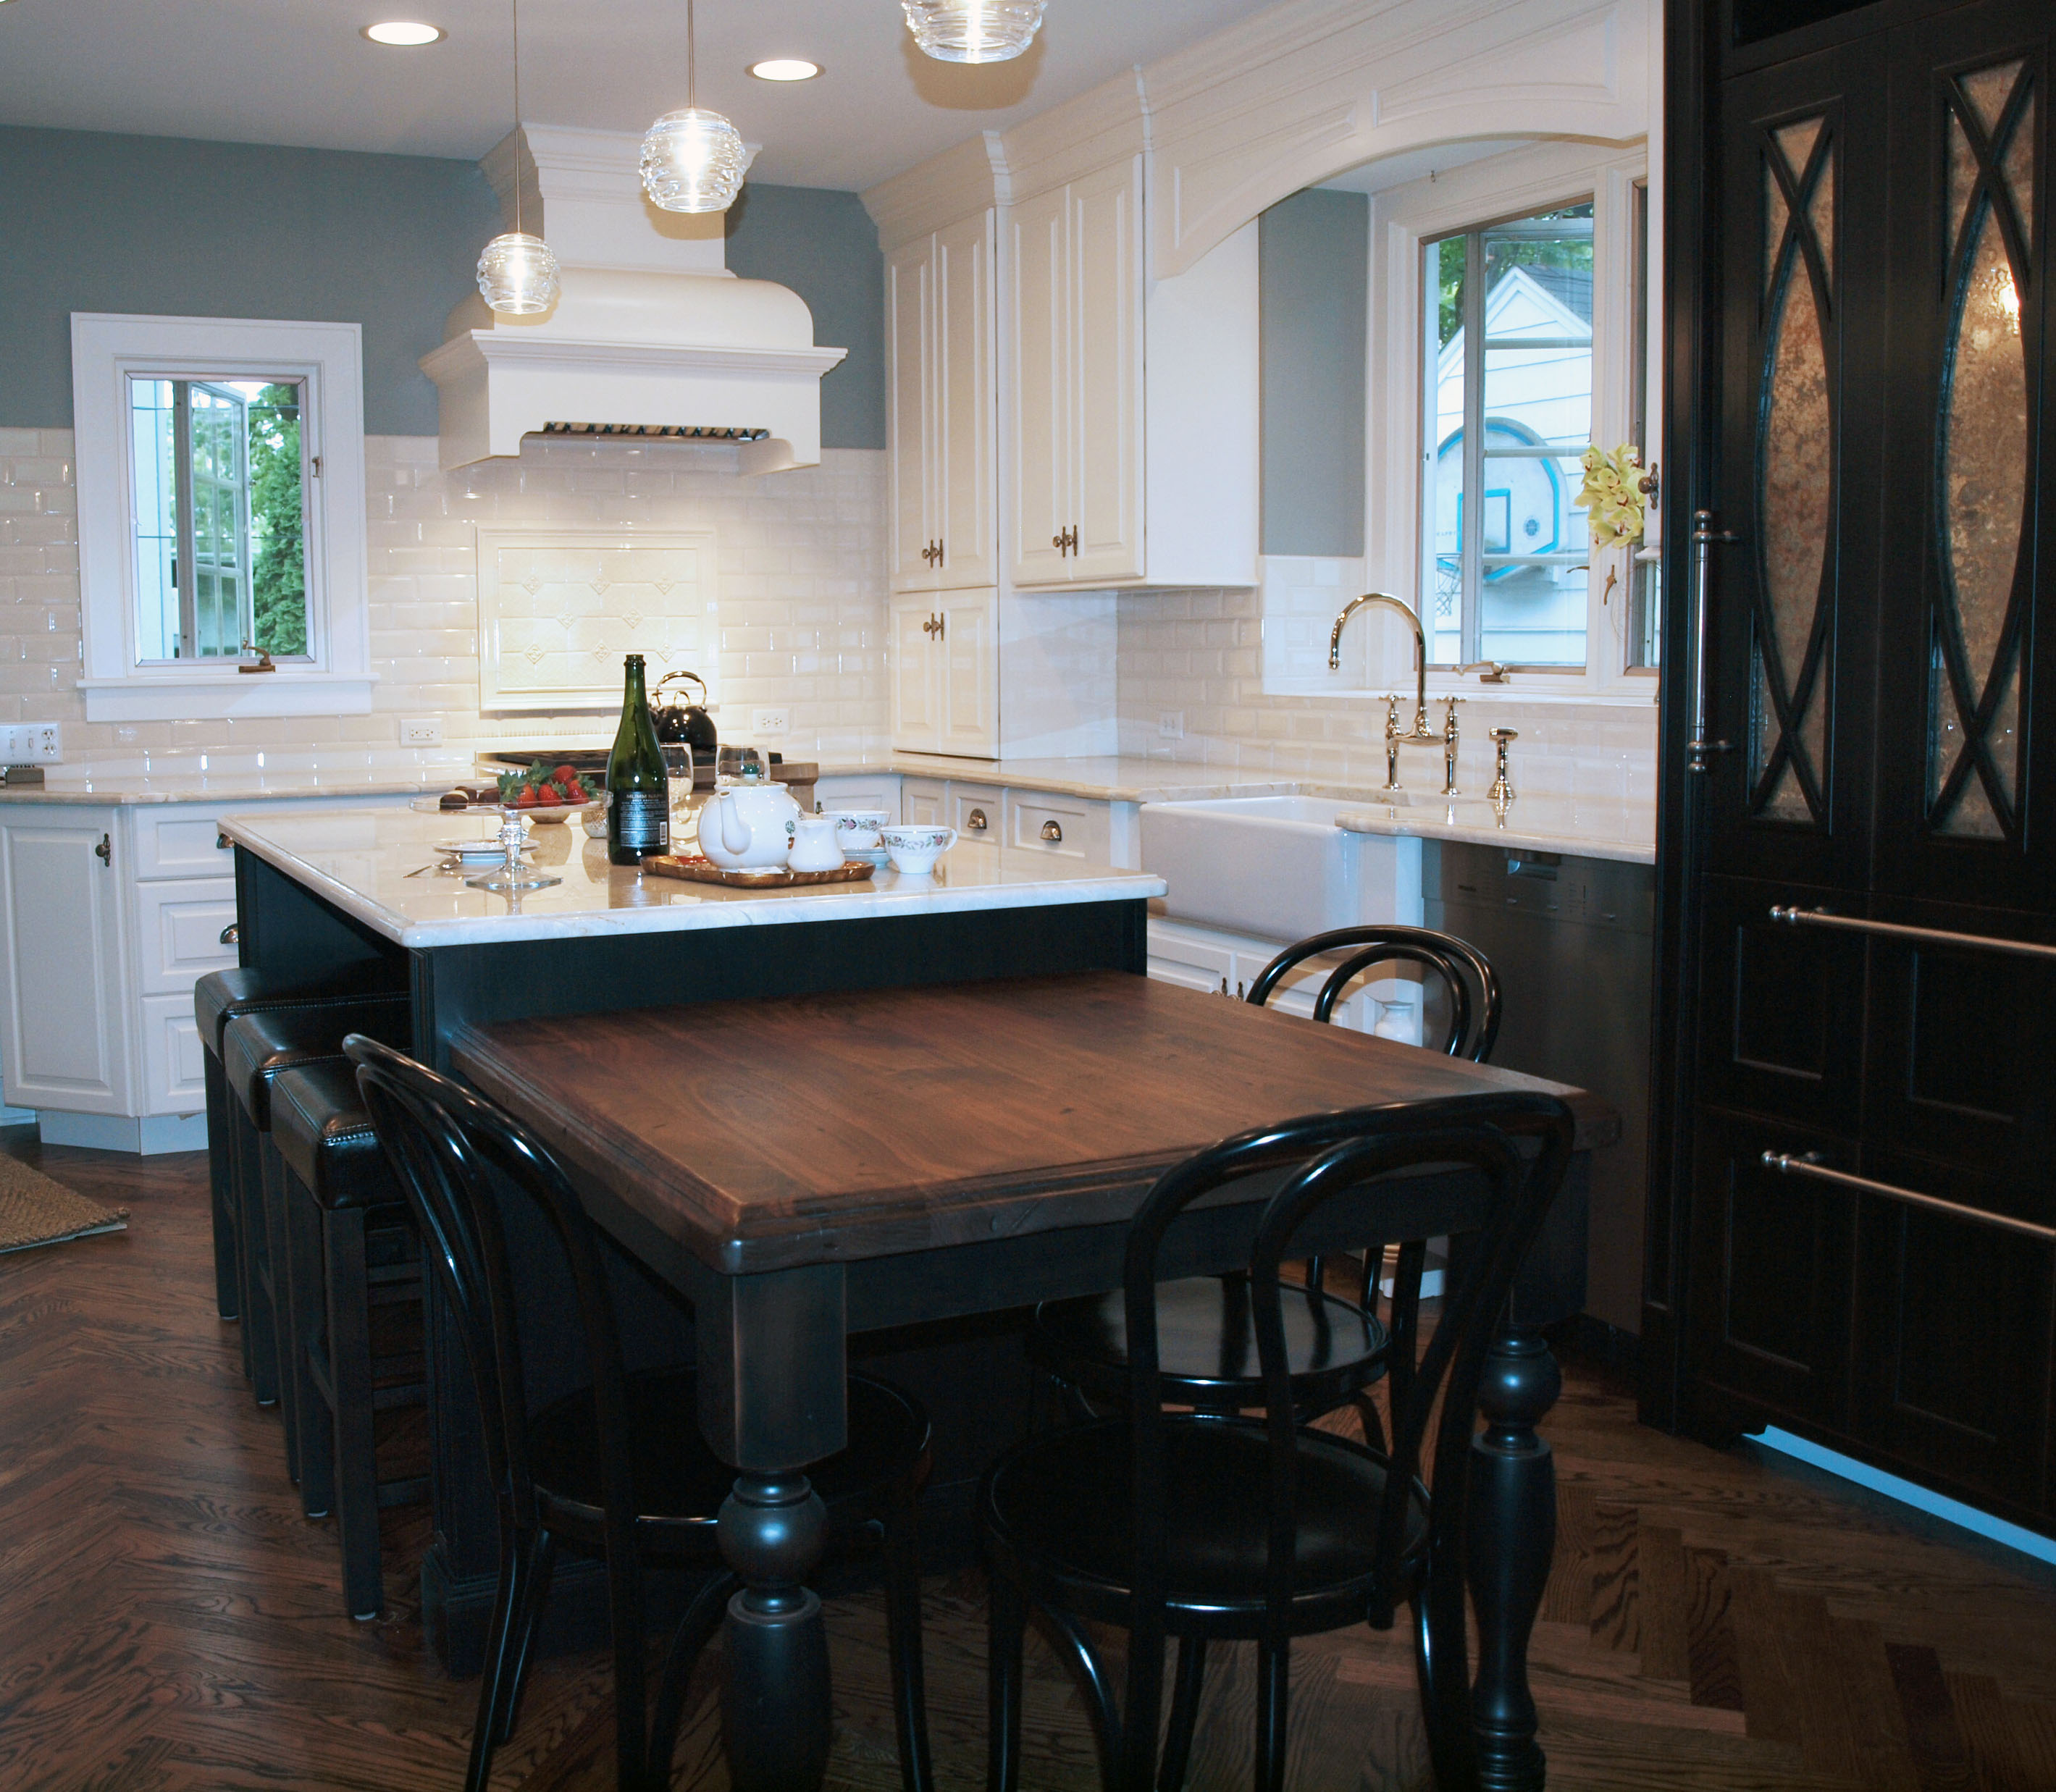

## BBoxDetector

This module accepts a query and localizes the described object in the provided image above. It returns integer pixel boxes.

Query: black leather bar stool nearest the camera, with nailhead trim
[272,1059,428,1618]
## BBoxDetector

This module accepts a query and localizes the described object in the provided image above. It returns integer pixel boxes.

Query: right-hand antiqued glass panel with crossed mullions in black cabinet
[1929,62,2036,838]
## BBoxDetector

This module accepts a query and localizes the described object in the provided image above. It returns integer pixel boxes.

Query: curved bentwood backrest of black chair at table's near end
[1123,1091,1573,1784]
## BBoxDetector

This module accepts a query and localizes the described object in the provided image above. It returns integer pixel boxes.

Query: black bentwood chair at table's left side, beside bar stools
[343,1036,933,1792]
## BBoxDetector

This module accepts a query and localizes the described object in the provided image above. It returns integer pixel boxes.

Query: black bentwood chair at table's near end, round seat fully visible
[978,1093,1573,1792]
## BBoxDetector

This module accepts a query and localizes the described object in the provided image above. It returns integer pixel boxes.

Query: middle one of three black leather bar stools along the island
[222,995,409,1480]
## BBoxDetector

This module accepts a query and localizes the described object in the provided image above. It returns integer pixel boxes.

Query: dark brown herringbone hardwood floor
[0,1130,2056,1792]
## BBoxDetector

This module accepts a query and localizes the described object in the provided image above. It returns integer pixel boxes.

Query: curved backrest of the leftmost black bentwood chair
[343,1034,635,1560]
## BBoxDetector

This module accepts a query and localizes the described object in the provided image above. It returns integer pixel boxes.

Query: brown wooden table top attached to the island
[453,972,1620,1274]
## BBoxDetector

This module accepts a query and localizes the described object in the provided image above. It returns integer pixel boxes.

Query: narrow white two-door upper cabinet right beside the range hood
[886,208,999,592]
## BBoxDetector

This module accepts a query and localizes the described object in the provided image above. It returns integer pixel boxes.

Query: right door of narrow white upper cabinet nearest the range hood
[927,211,999,590]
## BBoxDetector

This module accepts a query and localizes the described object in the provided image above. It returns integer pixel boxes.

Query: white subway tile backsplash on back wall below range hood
[0,429,890,760]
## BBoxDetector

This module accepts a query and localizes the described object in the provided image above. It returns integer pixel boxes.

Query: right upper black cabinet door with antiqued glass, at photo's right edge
[1877,0,2056,933]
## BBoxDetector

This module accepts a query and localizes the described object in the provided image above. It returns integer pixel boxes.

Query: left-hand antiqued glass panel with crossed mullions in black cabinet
[1750,119,1836,826]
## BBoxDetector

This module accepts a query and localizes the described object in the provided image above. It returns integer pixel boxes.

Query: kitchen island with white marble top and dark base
[220,809,1164,1671]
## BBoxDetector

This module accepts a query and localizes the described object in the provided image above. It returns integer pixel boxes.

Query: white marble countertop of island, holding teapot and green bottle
[222,809,1164,949]
